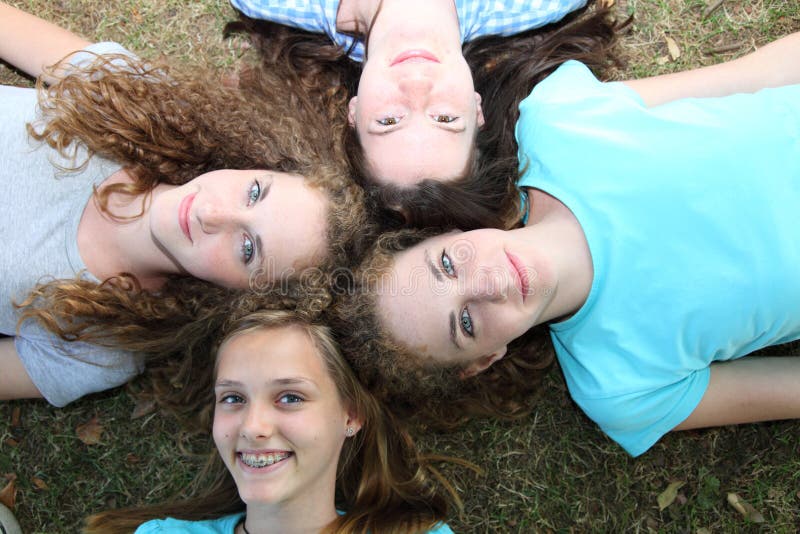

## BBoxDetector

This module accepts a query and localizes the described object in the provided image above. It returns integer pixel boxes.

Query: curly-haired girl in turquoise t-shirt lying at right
[324,30,800,455]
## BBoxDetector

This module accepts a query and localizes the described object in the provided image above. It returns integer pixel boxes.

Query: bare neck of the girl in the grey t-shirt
[78,170,178,289]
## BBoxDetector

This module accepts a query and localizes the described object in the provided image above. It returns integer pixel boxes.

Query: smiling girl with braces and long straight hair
[86,311,456,534]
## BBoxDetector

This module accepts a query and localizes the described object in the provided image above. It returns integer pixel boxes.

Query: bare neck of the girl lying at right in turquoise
[520,189,594,324]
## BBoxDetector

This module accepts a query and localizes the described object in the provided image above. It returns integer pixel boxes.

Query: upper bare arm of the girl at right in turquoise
[623,32,800,106]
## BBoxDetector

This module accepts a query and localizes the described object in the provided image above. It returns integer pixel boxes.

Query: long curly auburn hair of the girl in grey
[15,44,369,360]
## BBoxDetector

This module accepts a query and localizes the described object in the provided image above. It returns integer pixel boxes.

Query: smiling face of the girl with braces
[213,326,359,511]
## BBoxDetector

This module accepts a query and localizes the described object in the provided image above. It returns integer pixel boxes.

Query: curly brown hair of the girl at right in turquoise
[323,230,554,428]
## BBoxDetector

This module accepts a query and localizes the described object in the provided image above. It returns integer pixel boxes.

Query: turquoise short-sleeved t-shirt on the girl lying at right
[516,61,800,456]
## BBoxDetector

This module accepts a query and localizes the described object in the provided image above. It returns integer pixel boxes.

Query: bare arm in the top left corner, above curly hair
[0,3,90,82]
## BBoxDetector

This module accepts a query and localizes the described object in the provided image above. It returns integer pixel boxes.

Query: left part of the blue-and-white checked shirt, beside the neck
[231,0,364,61]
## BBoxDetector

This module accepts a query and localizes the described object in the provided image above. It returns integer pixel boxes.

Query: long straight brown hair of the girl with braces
[85,311,460,534]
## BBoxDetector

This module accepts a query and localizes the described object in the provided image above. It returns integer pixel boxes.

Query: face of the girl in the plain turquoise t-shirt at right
[377,229,553,375]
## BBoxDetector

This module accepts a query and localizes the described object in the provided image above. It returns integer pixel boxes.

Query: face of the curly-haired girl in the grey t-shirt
[148,170,328,288]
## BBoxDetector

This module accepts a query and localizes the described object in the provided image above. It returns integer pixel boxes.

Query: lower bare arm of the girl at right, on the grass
[674,356,800,430]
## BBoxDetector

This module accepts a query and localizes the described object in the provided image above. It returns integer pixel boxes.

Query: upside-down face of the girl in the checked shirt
[349,49,483,185]
